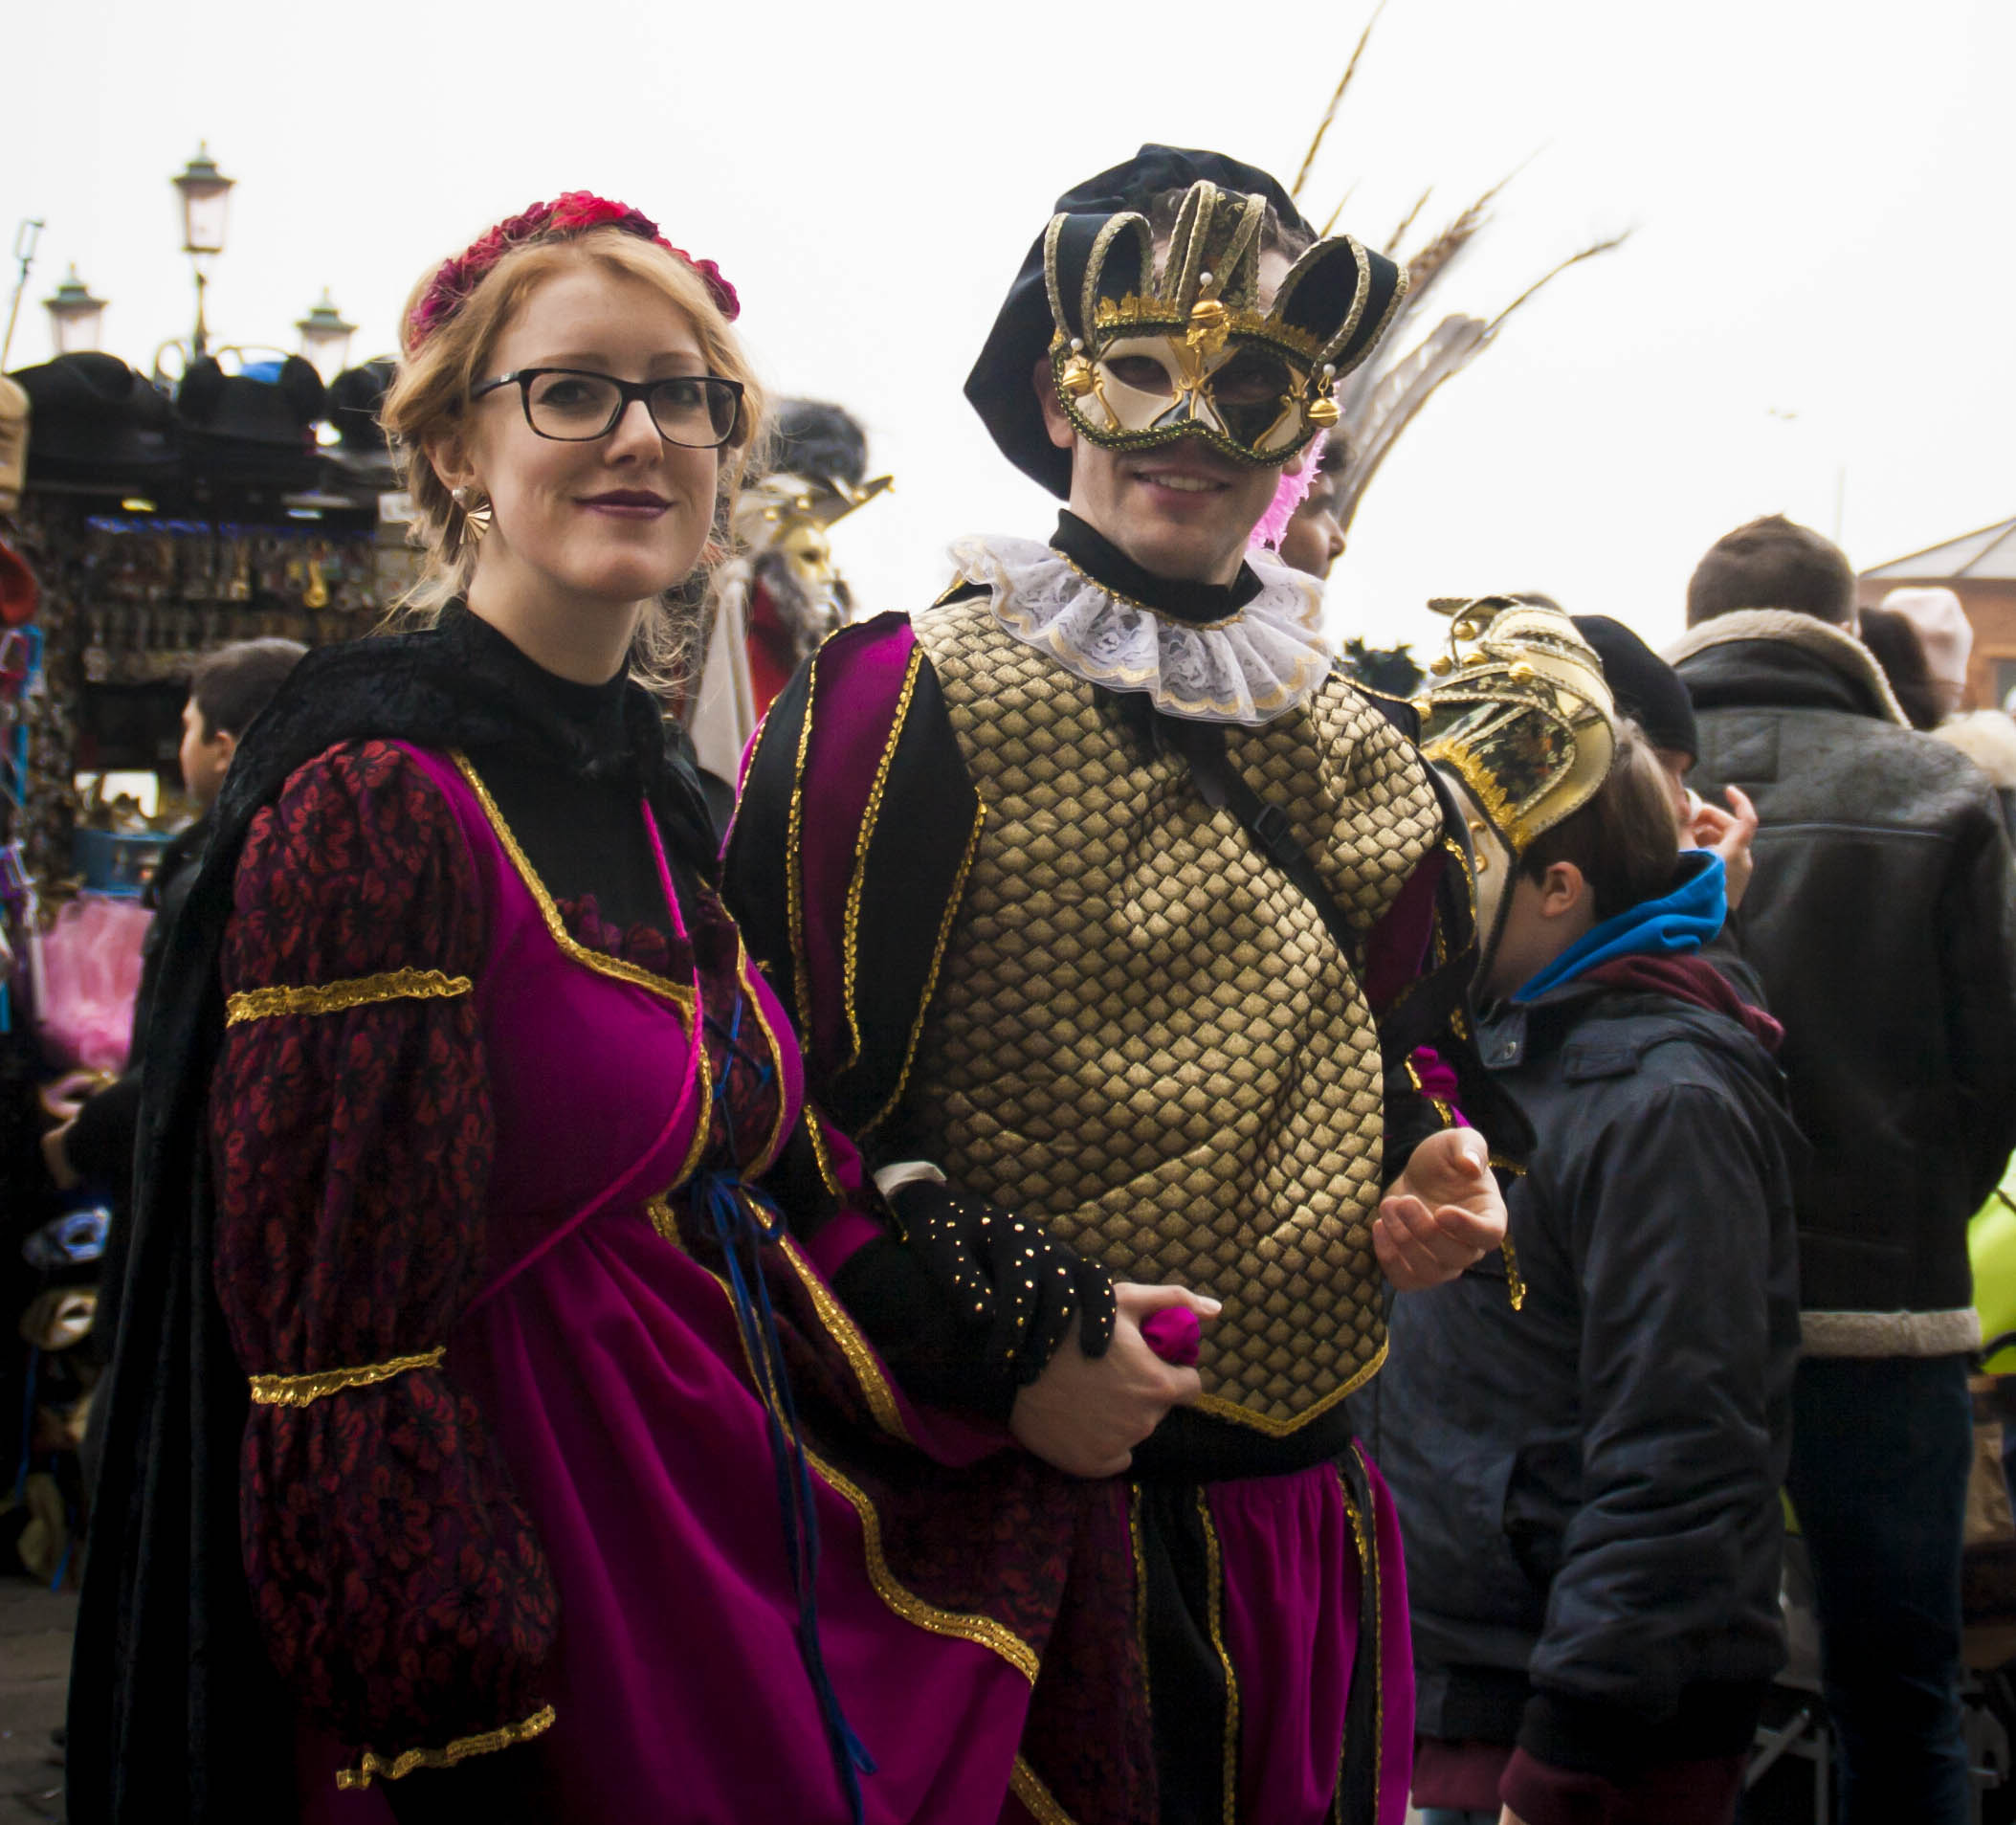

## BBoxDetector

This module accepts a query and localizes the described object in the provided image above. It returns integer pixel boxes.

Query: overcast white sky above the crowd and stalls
[0,0,2016,641]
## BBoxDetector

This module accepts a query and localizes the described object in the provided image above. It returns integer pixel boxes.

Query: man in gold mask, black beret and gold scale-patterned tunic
[726,145,1520,1825]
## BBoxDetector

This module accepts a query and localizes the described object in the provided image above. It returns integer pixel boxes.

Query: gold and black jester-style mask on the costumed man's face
[1042,180,1407,466]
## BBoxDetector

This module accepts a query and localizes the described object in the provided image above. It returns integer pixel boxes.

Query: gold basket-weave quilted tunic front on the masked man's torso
[913,597,1442,1434]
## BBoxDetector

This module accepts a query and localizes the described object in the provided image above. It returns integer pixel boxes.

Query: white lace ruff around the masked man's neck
[952,539,1331,728]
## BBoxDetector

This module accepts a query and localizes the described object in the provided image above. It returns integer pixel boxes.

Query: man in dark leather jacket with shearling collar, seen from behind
[1670,516,2016,1825]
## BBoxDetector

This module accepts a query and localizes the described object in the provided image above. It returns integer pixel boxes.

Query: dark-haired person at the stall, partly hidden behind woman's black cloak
[42,639,308,1347]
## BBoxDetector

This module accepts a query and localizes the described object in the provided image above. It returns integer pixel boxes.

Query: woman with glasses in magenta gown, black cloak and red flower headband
[69,193,1137,1825]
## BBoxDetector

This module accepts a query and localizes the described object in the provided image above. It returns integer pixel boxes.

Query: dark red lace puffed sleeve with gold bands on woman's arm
[210,742,557,1785]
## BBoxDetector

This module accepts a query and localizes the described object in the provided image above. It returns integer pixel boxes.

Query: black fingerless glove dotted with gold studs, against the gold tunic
[885,1180,1115,1388]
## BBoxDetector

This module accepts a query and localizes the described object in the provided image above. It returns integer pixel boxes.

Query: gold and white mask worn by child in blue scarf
[1415,595,1617,857]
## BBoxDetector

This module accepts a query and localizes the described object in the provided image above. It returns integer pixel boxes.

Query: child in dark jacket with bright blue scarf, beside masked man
[1377,616,1801,1825]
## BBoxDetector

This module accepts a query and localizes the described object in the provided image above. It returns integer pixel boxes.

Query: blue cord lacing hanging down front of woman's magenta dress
[694,996,875,1825]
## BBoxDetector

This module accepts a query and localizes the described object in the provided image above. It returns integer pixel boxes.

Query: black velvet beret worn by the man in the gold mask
[965,144,1313,501]
